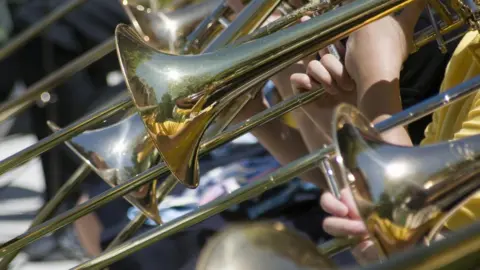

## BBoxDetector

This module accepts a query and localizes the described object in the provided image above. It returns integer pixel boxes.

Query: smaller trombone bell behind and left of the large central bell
[48,109,161,224]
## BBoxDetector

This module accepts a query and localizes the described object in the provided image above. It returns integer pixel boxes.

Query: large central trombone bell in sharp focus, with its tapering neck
[116,0,416,188]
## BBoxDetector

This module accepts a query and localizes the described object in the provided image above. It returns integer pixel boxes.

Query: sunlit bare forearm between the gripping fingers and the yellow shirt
[349,0,425,119]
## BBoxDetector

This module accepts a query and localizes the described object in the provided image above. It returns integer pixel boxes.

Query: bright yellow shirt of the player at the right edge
[421,31,480,230]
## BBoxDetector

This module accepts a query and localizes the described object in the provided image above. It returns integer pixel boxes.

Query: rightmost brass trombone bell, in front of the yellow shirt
[333,104,480,256]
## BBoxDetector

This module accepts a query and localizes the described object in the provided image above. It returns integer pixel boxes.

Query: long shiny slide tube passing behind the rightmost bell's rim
[73,73,480,270]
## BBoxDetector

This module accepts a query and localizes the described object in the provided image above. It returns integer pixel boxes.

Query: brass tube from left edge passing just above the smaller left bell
[0,99,133,174]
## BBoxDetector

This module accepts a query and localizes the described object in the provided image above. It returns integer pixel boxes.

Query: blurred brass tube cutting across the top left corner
[0,0,87,61]
